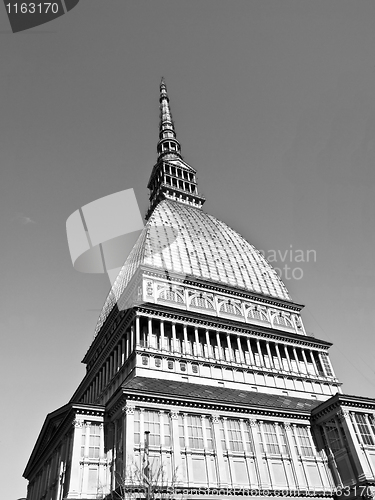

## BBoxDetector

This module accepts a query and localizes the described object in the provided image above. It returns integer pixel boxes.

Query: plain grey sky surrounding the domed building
[0,0,375,499]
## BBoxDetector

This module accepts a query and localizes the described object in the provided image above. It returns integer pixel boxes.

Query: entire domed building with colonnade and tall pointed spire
[24,80,375,500]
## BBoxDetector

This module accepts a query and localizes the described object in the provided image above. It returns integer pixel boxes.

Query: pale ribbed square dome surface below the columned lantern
[96,200,291,331]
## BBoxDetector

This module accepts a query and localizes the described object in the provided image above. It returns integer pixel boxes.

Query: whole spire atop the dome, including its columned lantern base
[146,78,205,220]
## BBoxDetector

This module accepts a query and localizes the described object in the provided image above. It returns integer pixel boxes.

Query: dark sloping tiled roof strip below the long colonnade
[122,377,320,413]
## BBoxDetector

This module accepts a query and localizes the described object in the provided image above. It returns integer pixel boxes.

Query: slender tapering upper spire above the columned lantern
[158,78,181,161]
